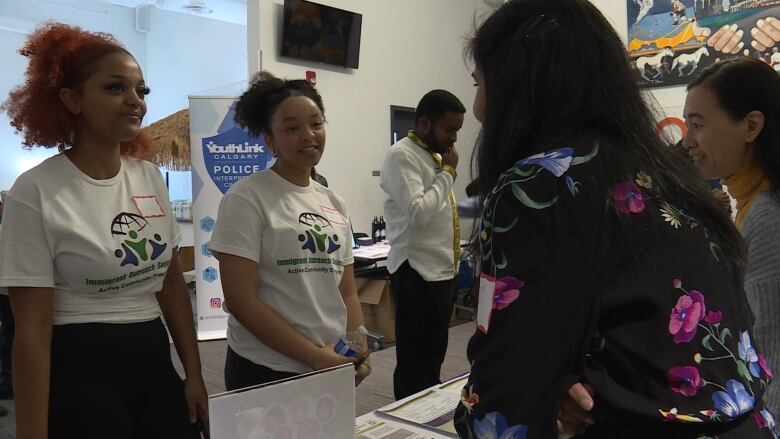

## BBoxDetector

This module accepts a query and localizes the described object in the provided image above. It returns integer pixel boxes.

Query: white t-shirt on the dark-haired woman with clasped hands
[209,169,353,373]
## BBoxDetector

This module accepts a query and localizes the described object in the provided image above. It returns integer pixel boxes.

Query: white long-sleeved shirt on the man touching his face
[380,137,456,281]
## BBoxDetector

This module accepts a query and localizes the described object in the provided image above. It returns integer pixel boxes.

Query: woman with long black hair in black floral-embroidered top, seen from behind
[456,0,774,438]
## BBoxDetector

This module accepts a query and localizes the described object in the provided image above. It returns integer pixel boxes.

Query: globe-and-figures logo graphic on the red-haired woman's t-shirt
[111,212,168,267]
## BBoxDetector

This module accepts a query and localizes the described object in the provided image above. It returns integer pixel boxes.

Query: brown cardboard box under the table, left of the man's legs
[355,277,395,342]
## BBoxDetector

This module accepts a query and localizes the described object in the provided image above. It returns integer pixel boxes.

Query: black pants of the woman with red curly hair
[49,319,199,439]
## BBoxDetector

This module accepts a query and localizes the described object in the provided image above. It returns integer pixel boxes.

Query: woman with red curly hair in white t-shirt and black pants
[0,23,207,439]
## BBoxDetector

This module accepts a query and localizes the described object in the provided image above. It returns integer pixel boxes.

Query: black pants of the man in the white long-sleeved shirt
[390,261,455,399]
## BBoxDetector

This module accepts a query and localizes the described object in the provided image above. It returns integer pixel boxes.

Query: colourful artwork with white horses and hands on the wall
[626,0,780,87]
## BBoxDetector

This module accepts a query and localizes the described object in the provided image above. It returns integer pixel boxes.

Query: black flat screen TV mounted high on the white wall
[282,0,363,69]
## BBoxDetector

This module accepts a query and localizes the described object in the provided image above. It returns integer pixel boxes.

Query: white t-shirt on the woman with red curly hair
[0,154,180,325]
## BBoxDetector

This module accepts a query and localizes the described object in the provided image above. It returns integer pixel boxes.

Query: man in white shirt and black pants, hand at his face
[381,90,466,399]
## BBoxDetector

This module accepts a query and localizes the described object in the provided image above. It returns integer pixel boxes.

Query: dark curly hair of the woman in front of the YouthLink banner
[235,72,325,136]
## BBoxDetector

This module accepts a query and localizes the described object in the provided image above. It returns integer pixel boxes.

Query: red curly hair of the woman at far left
[0,22,149,155]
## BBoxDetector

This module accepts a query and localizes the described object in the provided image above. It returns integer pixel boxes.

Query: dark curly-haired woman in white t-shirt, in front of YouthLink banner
[209,72,370,390]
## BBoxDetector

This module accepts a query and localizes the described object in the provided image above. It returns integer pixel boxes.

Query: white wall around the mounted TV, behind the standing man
[249,0,494,237]
